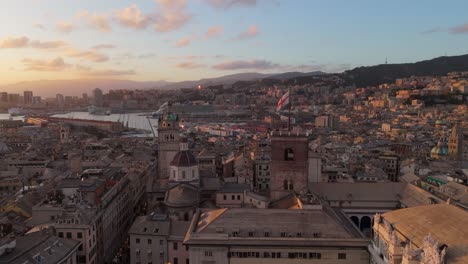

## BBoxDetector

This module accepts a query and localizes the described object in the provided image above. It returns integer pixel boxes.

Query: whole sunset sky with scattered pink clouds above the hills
[0,0,468,85]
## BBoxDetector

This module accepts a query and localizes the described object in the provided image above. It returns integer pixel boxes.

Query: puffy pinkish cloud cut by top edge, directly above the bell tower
[154,0,192,32]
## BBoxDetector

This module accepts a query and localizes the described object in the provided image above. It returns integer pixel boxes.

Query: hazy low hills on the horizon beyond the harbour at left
[0,79,168,97]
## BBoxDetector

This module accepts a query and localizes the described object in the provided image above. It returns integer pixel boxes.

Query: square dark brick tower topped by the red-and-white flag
[271,131,309,198]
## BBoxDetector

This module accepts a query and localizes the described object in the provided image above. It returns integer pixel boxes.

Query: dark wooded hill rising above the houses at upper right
[344,54,468,86]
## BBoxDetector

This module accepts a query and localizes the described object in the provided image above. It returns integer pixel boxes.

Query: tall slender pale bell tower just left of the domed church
[157,112,179,179]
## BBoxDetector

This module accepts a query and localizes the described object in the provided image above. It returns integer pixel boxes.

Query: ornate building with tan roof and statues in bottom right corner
[369,204,468,264]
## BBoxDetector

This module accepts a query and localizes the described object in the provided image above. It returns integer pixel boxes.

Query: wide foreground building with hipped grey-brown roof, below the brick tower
[184,208,369,264]
